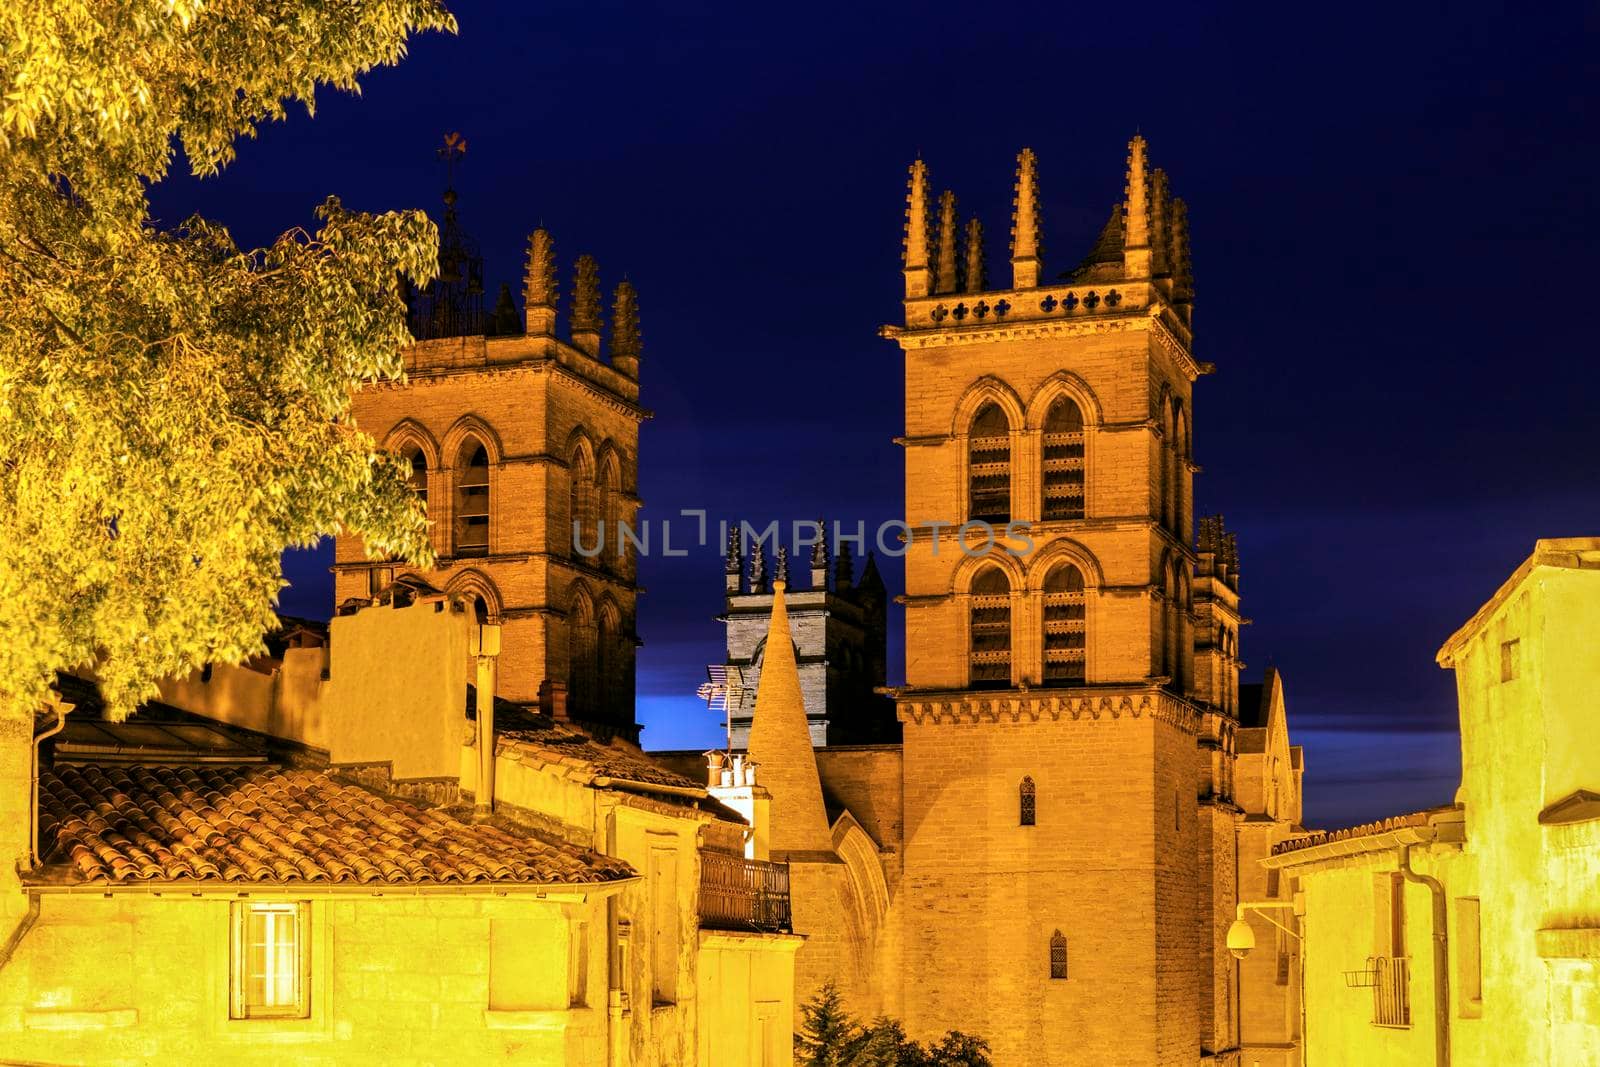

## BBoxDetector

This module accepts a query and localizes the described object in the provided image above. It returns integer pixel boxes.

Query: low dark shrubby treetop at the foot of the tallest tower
[797,982,990,1067]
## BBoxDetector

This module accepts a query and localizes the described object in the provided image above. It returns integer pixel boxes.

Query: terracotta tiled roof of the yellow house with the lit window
[37,766,634,885]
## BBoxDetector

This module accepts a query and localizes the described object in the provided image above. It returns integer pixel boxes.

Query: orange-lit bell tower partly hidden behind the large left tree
[334,194,648,736]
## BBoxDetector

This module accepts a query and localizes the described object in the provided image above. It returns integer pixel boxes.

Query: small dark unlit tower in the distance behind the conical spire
[723,523,899,749]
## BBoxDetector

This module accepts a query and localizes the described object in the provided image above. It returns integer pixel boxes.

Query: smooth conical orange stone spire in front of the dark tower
[749,579,834,859]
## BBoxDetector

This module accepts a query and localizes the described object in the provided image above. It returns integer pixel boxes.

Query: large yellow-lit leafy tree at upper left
[0,0,454,717]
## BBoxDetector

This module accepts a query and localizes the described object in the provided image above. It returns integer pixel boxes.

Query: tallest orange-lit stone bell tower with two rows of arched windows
[883,138,1235,1064]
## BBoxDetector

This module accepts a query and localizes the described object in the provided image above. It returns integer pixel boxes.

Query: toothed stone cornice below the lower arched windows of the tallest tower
[894,688,1200,736]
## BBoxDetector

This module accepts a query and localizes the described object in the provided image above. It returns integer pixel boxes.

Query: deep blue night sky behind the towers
[154,2,1600,825]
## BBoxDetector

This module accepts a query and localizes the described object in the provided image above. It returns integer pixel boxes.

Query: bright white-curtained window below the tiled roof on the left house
[229,904,310,1019]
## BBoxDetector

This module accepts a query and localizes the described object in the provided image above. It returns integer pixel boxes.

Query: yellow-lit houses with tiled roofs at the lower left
[0,582,798,1067]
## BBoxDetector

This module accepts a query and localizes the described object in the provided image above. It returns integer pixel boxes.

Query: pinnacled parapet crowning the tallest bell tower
[886,136,1210,358]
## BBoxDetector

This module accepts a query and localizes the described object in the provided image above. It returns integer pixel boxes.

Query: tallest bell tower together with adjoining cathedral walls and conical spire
[675,138,1299,1065]
